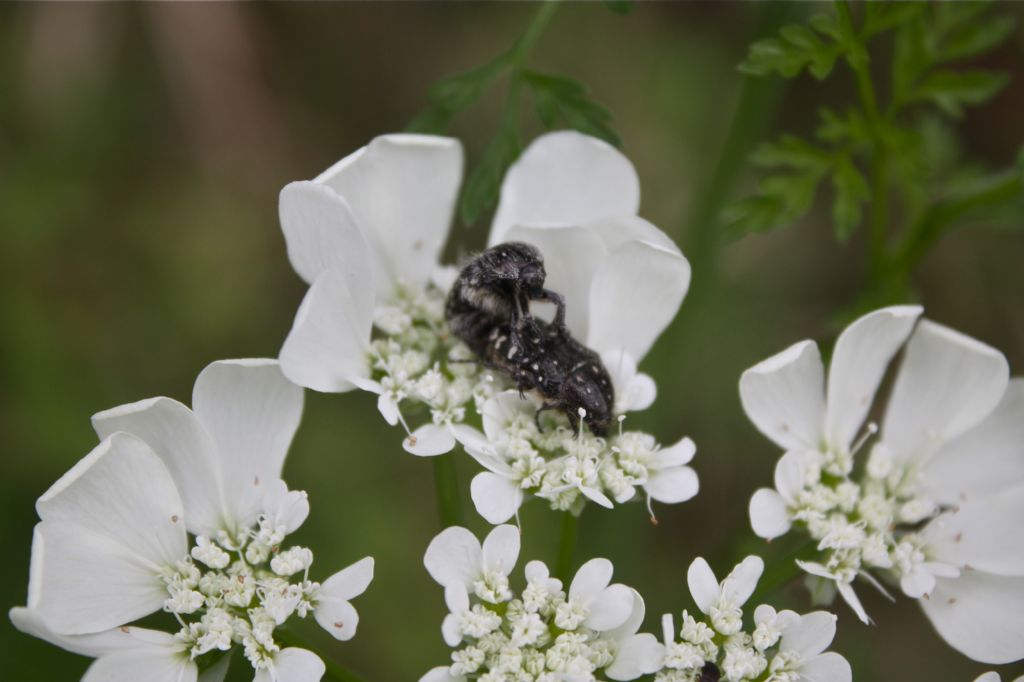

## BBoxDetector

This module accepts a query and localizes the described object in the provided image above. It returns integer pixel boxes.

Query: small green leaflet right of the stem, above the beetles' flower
[522,71,622,146]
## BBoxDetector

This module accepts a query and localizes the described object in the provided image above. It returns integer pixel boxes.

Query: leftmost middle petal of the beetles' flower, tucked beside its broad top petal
[278,181,374,303]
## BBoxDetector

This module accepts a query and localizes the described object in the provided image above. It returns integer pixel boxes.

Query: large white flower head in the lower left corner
[10,359,373,682]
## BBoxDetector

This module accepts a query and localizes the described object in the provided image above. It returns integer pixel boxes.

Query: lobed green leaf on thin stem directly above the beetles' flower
[407,2,632,225]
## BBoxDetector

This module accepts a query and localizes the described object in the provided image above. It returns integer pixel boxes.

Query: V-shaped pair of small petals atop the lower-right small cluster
[686,556,765,635]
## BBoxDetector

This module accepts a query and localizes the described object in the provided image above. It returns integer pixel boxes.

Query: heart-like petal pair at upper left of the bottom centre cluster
[423,525,519,603]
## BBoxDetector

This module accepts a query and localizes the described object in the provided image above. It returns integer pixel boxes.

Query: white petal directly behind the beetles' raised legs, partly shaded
[507,225,617,337]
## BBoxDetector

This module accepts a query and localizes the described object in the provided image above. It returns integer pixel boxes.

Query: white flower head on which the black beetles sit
[280,131,697,523]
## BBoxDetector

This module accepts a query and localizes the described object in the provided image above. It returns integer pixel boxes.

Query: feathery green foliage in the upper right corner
[725,2,1024,275]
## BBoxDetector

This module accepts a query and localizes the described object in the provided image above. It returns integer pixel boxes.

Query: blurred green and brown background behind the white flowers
[0,2,1024,681]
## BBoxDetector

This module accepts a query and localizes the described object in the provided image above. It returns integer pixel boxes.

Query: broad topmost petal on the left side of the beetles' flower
[315,134,463,301]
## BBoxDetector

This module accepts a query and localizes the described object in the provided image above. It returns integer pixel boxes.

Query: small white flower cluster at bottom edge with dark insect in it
[654,556,852,682]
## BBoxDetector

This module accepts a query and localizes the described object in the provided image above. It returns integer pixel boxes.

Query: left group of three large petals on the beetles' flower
[280,134,462,392]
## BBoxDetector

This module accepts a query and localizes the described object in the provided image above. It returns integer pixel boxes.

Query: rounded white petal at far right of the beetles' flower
[585,242,690,360]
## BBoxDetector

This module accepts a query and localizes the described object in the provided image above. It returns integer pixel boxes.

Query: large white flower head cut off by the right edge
[740,306,1024,664]
